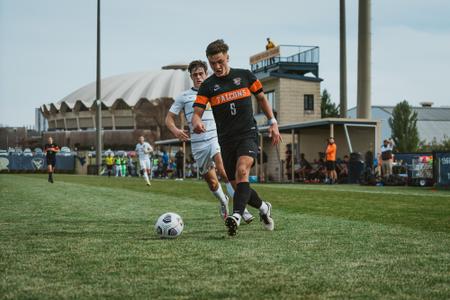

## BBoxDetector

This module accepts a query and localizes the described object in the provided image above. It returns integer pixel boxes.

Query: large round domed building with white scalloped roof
[41,64,191,149]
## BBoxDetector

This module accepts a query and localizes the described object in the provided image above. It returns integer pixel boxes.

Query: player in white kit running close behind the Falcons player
[166,60,254,223]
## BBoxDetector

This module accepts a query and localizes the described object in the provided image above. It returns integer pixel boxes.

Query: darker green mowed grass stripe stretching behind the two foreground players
[11,175,450,232]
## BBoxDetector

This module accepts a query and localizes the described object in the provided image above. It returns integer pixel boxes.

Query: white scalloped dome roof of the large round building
[42,69,191,111]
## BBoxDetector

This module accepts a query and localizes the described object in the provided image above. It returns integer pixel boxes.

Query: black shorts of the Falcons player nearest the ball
[220,137,258,180]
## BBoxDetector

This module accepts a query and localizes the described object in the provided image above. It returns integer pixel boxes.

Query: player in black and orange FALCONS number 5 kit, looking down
[192,40,281,235]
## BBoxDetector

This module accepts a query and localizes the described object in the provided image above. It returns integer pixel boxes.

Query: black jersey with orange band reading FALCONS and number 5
[194,69,263,144]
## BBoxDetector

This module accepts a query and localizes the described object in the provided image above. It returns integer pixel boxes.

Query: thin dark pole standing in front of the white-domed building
[95,0,102,175]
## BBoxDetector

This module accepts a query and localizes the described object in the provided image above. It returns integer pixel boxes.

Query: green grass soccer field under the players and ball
[0,174,450,299]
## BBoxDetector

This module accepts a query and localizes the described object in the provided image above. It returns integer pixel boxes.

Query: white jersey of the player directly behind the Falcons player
[169,88,217,151]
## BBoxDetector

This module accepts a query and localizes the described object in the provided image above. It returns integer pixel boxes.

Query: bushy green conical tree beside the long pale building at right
[389,100,420,152]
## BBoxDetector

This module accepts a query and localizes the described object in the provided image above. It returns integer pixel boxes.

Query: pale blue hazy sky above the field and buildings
[0,0,450,126]
